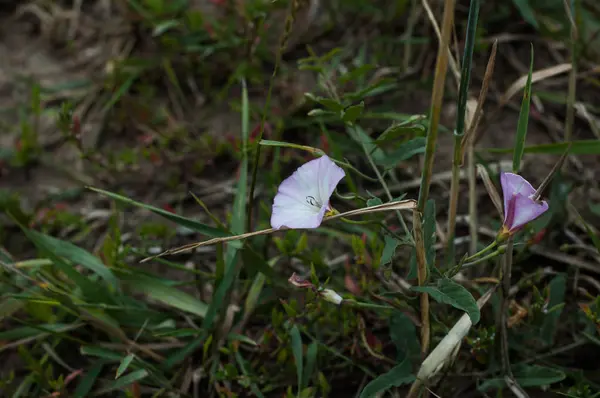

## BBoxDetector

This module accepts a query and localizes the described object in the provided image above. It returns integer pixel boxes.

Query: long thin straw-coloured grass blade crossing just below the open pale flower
[141,199,417,263]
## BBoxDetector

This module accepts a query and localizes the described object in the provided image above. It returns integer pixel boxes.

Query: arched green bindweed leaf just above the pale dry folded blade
[411,278,480,324]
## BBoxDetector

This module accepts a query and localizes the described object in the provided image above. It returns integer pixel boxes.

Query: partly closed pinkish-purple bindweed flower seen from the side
[500,173,548,234]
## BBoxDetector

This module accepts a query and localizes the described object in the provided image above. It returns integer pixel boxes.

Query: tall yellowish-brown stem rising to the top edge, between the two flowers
[413,0,455,356]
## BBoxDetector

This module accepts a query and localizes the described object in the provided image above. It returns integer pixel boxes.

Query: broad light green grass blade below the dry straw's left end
[121,274,207,317]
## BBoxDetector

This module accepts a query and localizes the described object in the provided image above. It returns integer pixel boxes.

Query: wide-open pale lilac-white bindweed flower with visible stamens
[271,156,346,229]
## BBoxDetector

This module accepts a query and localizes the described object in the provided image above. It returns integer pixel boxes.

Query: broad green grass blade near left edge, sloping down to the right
[27,230,119,290]
